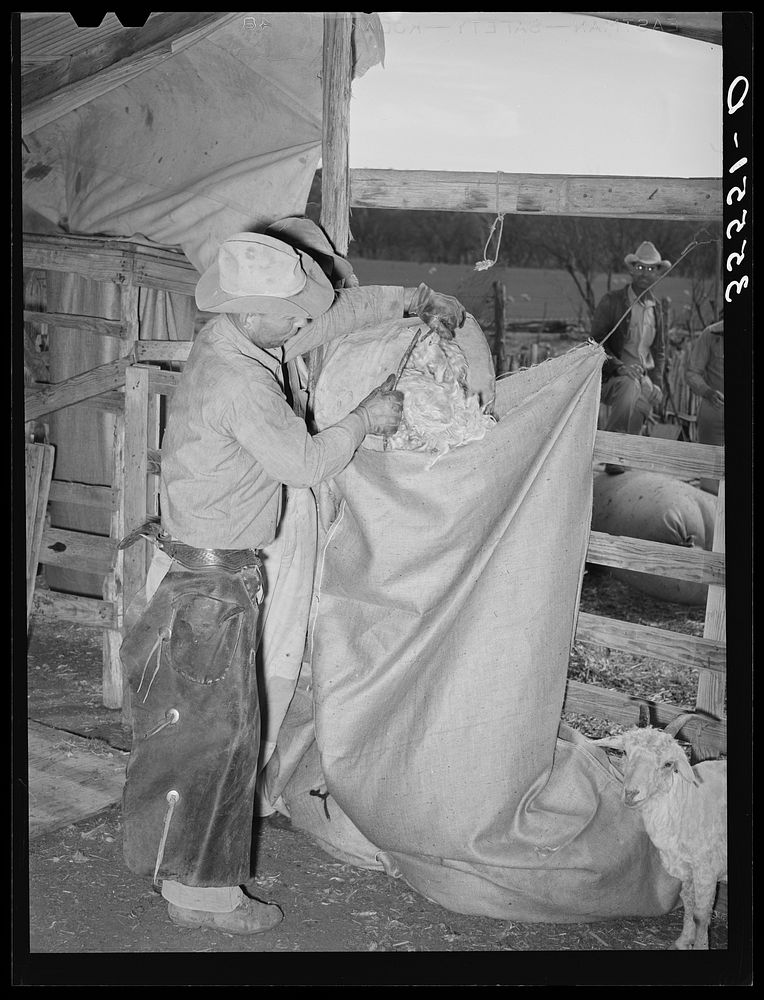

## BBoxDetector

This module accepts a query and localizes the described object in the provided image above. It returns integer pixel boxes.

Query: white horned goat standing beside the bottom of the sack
[592,726,727,950]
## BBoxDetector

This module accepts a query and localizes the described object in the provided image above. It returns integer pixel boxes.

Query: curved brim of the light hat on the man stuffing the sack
[194,249,334,319]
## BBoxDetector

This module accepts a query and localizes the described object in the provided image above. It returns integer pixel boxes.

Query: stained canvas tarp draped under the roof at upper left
[21,11,384,271]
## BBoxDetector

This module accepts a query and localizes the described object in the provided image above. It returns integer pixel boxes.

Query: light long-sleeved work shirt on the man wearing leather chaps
[160,286,403,549]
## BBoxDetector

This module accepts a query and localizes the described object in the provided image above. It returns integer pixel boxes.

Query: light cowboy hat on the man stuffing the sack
[195,233,334,319]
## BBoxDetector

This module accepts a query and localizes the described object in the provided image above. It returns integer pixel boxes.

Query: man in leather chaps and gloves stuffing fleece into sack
[121,227,465,934]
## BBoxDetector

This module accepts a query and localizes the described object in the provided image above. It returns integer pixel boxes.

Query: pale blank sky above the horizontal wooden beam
[350,11,723,177]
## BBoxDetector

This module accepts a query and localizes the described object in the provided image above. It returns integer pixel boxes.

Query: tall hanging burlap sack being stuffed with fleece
[266,331,678,922]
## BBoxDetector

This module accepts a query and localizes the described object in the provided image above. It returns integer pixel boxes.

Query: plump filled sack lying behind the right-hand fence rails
[592,471,716,605]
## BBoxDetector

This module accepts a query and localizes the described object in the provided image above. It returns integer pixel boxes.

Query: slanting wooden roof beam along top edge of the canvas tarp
[21,11,240,135]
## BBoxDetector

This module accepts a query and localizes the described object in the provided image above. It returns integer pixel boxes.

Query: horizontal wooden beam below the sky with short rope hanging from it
[350,169,723,222]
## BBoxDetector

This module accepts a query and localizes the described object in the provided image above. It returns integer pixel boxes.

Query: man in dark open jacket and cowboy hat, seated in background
[591,242,671,464]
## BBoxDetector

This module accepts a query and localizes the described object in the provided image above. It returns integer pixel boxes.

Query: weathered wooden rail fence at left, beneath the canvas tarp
[23,234,199,708]
